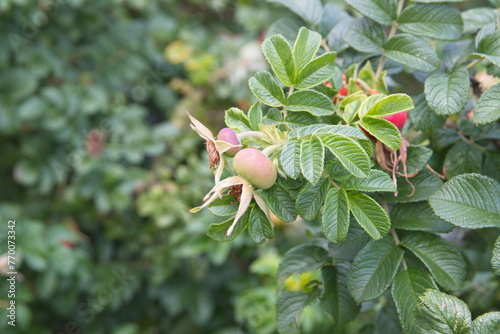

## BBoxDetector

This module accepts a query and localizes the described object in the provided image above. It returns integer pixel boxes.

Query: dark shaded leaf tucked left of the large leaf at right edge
[391,201,454,233]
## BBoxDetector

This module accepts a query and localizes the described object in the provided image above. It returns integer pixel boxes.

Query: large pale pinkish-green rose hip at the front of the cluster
[233,148,278,189]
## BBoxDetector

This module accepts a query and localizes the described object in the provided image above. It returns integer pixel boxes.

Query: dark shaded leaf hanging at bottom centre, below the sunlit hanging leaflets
[320,263,360,328]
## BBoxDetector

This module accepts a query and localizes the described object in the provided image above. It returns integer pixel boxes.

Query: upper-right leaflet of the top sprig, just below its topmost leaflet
[295,52,337,89]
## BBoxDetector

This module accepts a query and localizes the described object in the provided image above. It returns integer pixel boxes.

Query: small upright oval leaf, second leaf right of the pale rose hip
[300,135,325,184]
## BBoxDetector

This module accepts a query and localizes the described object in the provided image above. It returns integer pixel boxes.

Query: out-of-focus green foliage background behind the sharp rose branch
[0,0,498,334]
